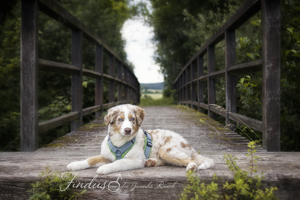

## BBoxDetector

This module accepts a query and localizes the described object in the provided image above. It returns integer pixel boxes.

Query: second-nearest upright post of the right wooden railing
[225,31,236,125]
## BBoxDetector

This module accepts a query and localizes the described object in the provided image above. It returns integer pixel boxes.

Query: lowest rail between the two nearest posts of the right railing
[229,113,263,132]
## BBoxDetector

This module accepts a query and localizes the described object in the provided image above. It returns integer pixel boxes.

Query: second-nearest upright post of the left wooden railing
[71,30,82,131]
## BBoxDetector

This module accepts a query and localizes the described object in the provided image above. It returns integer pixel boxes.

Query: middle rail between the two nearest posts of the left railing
[38,59,80,74]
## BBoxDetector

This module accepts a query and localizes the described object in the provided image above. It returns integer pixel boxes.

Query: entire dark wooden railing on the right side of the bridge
[174,0,280,151]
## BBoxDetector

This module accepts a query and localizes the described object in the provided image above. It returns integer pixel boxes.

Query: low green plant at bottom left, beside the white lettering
[27,168,86,200]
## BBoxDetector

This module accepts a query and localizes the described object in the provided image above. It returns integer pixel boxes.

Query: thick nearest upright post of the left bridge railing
[20,0,39,151]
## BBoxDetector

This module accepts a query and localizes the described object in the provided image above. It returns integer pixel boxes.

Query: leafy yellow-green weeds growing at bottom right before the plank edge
[181,142,278,200]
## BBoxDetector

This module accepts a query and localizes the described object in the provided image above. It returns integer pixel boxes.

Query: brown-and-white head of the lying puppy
[104,104,145,136]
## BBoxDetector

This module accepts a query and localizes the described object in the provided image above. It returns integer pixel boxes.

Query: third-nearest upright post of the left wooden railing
[95,45,103,119]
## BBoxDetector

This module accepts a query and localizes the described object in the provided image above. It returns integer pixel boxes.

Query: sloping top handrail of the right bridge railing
[174,0,261,83]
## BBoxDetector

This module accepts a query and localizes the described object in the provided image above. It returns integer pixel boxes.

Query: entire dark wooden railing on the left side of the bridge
[21,0,140,151]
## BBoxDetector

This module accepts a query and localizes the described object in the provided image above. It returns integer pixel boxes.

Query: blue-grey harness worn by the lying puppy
[108,130,152,160]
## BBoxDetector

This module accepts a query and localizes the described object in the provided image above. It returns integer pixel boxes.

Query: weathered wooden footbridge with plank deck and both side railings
[0,0,300,199]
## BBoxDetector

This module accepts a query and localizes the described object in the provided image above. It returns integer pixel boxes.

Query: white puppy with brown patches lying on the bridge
[67,104,214,174]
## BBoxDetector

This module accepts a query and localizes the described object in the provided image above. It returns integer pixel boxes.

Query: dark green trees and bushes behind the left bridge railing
[0,0,134,151]
